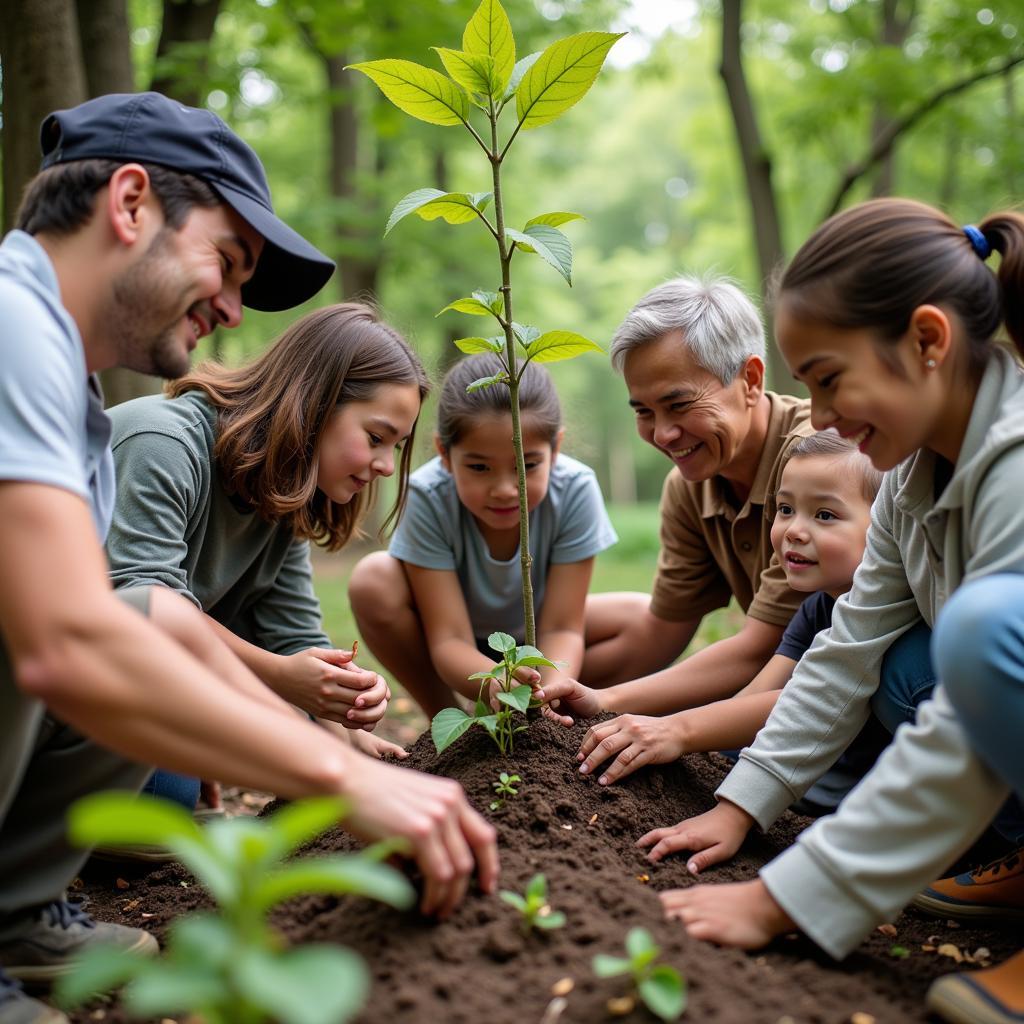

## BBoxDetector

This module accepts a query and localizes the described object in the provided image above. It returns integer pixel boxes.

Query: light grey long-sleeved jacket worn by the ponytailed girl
[717,348,1024,957]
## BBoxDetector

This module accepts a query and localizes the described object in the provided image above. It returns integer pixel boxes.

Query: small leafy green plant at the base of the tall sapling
[430,633,558,755]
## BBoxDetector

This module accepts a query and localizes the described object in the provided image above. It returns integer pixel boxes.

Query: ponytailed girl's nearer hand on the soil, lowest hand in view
[658,879,797,949]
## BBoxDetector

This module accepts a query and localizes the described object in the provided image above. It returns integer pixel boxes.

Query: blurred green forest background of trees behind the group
[0,0,1024,501]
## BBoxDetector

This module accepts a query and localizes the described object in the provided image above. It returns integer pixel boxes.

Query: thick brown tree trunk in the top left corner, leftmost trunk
[0,0,86,230]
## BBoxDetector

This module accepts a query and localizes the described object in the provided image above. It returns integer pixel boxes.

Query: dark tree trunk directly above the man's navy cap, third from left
[151,0,220,106]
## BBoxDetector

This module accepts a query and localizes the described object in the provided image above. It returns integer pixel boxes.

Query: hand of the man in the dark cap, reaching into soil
[343,757,499,918]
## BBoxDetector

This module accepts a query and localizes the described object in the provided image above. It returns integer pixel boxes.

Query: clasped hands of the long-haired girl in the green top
[278,647,391,731]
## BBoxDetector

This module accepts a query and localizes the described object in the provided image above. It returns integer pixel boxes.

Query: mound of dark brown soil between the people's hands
[79,720,1019,1024]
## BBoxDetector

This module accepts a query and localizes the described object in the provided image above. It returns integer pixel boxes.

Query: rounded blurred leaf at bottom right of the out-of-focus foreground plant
[234,945,370,1024]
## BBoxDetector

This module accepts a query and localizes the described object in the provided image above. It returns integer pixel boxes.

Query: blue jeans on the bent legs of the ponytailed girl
[871,602,1024,844]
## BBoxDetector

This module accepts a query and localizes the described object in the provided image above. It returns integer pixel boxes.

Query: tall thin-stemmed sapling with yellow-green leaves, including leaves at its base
[350,0,624,754]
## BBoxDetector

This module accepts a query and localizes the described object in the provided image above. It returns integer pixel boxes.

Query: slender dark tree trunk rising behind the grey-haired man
[719,0,793,391]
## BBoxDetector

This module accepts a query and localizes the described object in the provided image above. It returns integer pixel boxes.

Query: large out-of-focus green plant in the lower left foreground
[56,793,414,1024]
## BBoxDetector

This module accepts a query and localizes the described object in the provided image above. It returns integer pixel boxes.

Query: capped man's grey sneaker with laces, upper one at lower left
[0,900,160,985]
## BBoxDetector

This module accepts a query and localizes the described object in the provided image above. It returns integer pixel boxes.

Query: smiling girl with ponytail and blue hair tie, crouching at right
[640,199,1024,1022]
